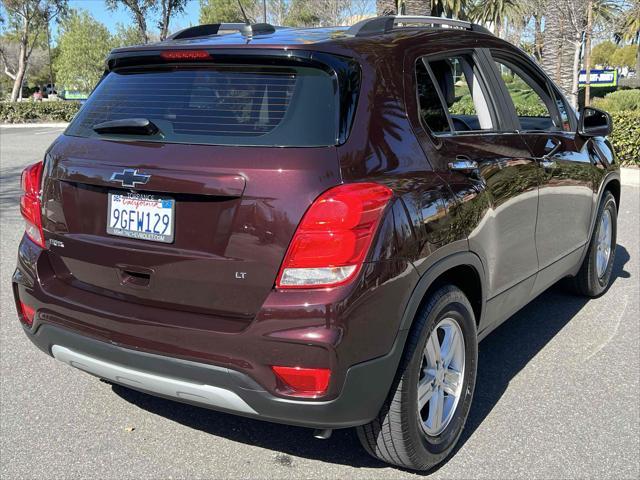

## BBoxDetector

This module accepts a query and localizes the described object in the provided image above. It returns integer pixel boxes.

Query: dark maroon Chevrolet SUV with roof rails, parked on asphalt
[13,17,620,469]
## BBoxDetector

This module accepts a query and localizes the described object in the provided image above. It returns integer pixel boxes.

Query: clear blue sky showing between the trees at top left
[69,0,200,36]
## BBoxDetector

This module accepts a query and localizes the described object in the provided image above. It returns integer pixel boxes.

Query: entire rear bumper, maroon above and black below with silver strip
[13,237,414,428]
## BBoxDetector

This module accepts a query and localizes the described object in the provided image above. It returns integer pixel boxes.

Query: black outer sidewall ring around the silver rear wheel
[403,289,478,463]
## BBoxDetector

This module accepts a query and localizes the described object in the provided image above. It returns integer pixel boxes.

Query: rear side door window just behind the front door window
[416,55,494,134]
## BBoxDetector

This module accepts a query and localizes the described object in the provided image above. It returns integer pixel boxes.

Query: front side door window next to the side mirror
[495,60,570,131]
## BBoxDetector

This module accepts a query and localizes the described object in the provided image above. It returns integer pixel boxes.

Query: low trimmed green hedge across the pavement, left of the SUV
[0,101,80,123]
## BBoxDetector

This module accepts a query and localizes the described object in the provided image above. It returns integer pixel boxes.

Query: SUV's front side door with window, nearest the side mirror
[491,50,600,269]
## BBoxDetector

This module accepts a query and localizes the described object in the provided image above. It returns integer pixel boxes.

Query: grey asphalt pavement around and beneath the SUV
[0,127,640,480]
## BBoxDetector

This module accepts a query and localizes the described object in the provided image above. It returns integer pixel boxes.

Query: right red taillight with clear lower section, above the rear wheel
[276,183,392,288]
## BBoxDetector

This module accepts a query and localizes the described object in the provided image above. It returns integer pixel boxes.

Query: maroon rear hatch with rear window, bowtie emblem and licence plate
[43,50,350,332]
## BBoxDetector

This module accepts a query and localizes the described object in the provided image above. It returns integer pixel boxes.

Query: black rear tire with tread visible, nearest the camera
[357,285,478,470]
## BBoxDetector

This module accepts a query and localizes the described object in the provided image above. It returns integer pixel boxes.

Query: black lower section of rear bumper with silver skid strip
[25,324,399,428]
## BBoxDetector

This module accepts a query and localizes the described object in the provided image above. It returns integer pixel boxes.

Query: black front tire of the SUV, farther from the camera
[571,191,618,298]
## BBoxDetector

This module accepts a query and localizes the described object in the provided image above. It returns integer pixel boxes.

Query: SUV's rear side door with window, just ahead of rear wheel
[406,45,539,300]
